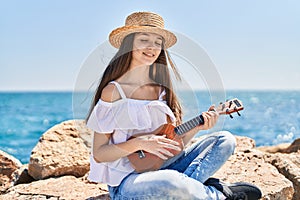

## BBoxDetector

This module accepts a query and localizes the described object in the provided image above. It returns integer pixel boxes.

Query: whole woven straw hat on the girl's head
[109,12,177,49]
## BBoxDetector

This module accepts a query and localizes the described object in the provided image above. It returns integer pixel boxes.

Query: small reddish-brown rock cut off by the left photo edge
[0,150,22,193]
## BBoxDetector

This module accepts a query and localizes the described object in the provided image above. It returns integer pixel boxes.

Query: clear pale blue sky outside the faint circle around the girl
[0,0,300,91]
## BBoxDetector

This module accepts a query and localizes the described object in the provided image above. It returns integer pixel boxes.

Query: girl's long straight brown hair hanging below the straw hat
[87,33,182,124]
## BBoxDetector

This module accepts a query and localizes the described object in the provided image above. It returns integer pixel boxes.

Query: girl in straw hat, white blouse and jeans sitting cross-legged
[87,12,261,199]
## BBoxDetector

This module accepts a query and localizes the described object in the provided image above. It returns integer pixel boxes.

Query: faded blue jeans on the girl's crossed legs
[108,131,236,200]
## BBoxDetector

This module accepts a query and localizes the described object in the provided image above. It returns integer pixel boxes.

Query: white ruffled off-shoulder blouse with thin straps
[87,81,175,186]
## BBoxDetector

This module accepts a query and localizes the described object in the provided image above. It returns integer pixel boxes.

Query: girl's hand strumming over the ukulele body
[136,135,181,160]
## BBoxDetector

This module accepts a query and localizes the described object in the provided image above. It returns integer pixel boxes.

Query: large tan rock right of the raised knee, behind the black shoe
[214,136,294,200]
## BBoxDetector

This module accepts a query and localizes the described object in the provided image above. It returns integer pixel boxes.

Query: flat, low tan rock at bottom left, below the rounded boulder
[0,176,109,200]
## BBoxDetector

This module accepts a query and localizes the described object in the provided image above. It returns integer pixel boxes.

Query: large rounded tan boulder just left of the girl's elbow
[28,120,91,180]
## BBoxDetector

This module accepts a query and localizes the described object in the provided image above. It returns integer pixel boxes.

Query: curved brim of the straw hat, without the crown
[109,26,177,49]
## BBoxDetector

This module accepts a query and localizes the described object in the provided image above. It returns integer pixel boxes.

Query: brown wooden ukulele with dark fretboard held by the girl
[127,98,244,173]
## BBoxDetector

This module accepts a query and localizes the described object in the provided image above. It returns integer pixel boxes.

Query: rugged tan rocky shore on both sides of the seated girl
[0,120,300,200]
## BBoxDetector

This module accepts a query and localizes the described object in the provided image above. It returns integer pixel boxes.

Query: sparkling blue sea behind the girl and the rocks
[0,90,300,164]
